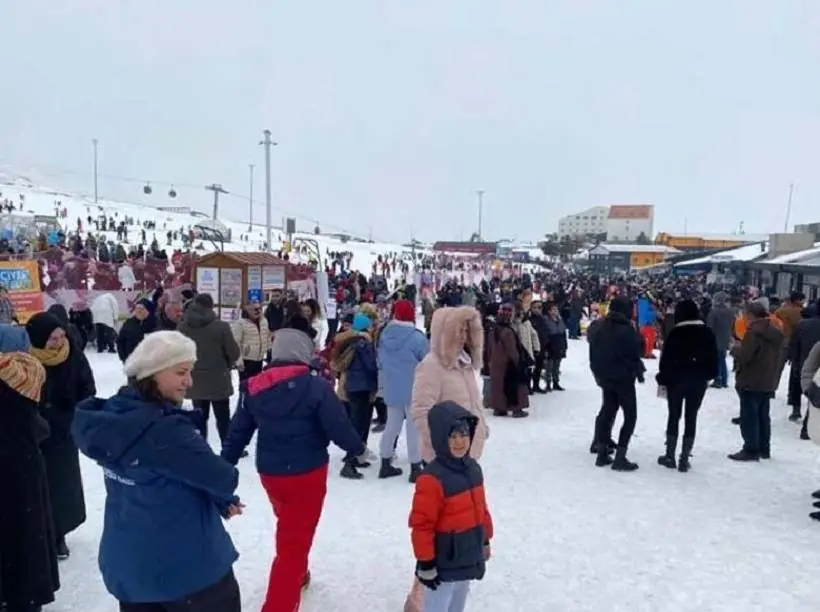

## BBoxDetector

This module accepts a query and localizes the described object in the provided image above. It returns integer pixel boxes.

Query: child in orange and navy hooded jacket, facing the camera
[410,402,493,612]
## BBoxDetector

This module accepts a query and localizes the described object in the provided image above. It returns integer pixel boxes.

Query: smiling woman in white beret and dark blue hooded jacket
[72,331,242,612]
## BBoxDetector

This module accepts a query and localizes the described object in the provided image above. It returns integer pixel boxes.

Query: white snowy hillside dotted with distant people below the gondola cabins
[0,172,421,271]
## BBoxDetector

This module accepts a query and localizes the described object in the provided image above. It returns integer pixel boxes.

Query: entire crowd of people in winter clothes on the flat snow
[0,258,820,612]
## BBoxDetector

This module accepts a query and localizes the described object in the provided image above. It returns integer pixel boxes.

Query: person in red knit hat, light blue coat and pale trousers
[377,300,430,483]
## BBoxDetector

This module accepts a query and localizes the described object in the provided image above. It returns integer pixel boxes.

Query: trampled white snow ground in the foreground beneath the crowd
[56,341,820,612]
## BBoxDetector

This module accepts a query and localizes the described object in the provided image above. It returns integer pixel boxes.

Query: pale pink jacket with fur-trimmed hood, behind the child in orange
[410,306,490,462]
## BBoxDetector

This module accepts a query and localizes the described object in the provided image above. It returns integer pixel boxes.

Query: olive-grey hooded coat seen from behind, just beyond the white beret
[177,304,241,400]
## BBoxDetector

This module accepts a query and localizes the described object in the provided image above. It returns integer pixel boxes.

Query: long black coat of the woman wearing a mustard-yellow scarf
[40,343,97,537]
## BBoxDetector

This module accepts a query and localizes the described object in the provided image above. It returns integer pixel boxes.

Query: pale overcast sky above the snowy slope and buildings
[0,0,820,240]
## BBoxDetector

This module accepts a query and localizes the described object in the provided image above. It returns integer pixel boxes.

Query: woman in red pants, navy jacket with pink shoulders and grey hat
[222,319,366,612]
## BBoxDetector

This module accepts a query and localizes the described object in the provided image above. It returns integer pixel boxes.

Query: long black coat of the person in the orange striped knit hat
[0,382,60,609]
